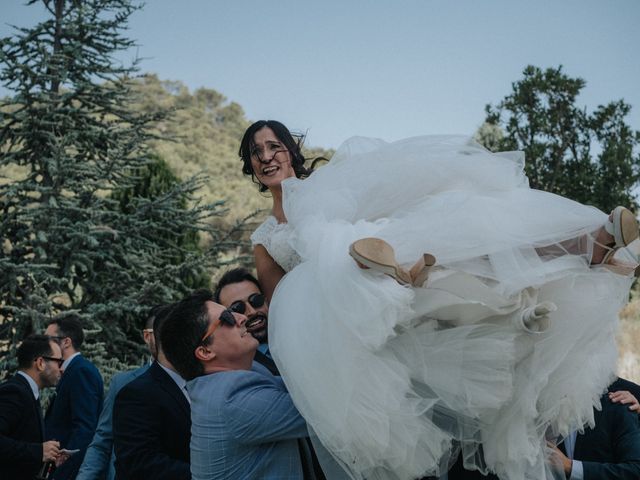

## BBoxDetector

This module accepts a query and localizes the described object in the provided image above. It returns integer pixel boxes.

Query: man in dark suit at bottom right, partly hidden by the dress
[552,383,640,480]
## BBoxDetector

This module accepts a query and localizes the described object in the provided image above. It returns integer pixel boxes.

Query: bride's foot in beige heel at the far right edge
[591,207,640,265]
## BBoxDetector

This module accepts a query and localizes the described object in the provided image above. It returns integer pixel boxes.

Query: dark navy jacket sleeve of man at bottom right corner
[582,405,640,480]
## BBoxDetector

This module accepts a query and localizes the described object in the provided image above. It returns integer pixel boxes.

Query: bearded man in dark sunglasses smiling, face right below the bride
[213,268,280,375]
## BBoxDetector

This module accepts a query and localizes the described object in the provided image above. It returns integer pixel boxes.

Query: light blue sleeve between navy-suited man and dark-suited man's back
[76,372,132,480]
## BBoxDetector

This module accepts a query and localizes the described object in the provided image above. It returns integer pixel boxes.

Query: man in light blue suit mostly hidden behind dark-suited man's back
[76,306,166,480]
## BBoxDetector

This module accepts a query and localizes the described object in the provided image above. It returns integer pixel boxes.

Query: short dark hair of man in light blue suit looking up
[161,290,213,380]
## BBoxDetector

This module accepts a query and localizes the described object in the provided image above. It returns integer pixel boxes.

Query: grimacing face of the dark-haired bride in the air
[251,127,296,188]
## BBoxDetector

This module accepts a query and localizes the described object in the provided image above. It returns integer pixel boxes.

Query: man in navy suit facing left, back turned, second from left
[45,315,104,480]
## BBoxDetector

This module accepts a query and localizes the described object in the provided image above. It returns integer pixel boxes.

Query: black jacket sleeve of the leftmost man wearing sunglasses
[0,385,42,464]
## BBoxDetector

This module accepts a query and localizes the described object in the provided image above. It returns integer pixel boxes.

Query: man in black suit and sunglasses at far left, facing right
[0,335,62,480]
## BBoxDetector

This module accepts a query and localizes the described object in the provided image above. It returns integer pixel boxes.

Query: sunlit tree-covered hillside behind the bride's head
[128,74,332,229]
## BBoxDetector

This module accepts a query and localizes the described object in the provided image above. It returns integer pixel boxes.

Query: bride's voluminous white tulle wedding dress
[252,137,631,480]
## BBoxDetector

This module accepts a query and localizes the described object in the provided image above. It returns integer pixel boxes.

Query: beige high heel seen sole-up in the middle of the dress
[349,237,436,287]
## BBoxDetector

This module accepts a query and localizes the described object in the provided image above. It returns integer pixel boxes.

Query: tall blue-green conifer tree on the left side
[0,0,233,371]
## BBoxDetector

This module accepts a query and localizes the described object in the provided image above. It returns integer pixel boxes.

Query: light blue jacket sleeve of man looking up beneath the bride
[224,374,309,444]
